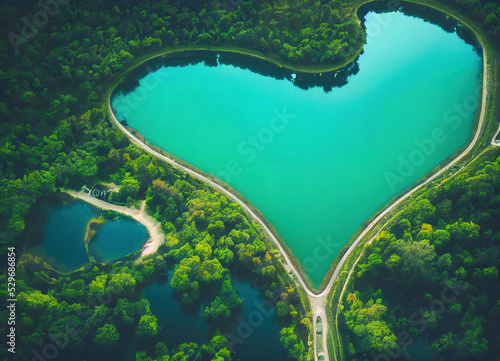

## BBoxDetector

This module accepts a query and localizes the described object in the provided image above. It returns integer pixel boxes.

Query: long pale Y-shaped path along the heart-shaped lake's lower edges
[102,17,497,360]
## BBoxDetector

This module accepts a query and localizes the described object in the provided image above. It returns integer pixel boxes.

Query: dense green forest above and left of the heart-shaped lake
[0,1,361,360]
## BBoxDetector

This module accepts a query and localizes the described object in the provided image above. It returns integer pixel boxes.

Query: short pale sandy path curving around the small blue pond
[62,189,165,257]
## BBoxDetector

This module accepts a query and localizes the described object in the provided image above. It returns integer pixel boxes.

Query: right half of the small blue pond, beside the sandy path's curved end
[89,218,149,263]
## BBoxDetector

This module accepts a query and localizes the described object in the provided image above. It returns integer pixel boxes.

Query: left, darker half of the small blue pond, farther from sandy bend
[30,202,94,272]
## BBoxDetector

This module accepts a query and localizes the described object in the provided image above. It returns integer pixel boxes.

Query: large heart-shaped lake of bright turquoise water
[112,12,482,286]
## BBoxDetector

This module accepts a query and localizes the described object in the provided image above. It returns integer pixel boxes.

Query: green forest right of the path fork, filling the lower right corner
[343,150,500,361]
